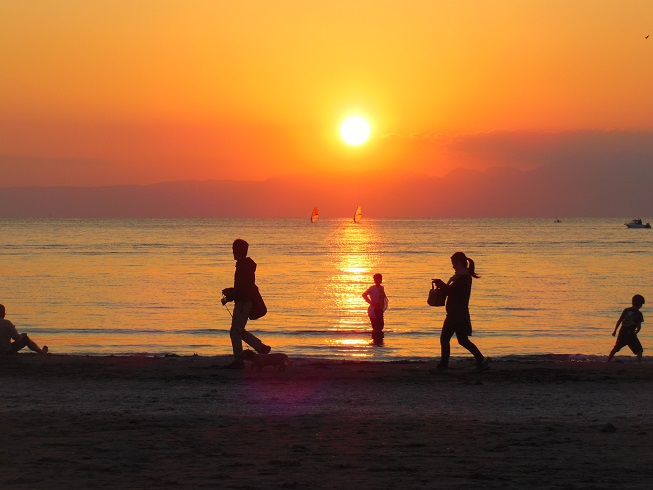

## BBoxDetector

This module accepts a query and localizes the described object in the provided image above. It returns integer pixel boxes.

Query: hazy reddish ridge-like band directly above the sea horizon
[0,160,653,218]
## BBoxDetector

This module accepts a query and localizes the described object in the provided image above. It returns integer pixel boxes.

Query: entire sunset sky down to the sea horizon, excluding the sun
[0,0,653,217]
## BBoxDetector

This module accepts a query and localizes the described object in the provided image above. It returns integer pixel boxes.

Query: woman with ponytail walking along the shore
[433,252,490,373]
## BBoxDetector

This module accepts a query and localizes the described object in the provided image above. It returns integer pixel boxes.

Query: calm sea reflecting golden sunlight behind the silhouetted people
[0,218,653,360]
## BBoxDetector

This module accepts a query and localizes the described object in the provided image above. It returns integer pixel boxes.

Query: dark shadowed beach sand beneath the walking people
[0,354,653,488]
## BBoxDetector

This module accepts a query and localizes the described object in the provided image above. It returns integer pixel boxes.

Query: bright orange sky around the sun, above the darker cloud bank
[0,0,653,186]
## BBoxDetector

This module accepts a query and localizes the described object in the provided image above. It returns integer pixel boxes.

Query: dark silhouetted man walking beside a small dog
[222,238,271,369]
